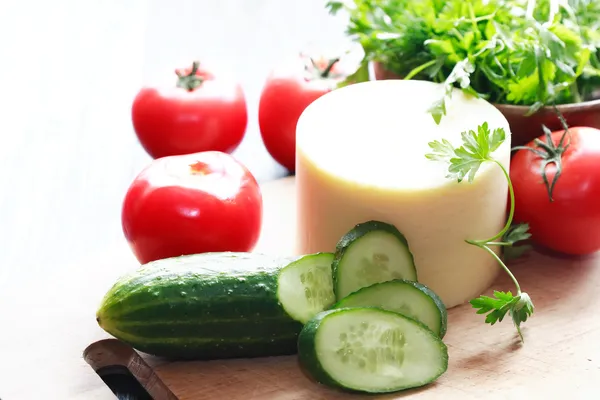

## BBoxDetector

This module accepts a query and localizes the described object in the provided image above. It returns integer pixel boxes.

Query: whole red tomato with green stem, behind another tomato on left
[131,62,248,158]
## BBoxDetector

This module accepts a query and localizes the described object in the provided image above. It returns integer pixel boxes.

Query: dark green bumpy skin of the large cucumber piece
[96,252,302,360]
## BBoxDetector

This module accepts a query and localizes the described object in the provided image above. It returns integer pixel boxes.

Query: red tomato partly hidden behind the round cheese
[258,55,347,172]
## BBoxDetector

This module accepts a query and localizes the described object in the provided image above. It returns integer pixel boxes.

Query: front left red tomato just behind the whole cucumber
[121,151,262,264]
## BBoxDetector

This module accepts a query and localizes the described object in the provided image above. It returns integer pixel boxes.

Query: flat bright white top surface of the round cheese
[296,80,510,190]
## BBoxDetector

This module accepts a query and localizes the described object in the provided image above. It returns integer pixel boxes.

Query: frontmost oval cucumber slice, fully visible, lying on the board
[298,307,448,393]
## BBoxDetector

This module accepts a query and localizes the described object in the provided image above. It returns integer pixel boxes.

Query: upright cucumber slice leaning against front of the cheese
[332,221,417,300]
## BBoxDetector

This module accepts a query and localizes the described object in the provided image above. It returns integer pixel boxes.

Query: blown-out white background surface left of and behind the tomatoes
[0,0,350,400]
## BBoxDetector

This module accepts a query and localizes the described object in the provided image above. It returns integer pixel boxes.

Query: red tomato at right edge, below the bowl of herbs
[510,127,600,255]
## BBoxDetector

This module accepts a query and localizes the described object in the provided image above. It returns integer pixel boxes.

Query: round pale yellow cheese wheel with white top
[296,80,510,307]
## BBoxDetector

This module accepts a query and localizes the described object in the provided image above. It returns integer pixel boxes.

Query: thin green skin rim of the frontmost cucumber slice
[298,307,448,394]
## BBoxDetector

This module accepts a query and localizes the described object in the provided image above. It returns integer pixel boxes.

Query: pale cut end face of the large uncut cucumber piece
[277,253,335,324]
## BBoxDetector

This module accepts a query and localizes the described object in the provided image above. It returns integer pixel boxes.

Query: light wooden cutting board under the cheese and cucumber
[84,177,600,400]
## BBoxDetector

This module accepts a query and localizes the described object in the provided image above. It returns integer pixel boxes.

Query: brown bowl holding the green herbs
[371,62,600,146]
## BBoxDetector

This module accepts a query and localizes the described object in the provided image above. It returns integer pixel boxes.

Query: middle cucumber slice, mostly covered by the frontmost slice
[333,279,448,338]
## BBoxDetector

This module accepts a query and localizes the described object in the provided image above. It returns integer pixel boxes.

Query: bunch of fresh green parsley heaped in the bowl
[327,0,600,123]
